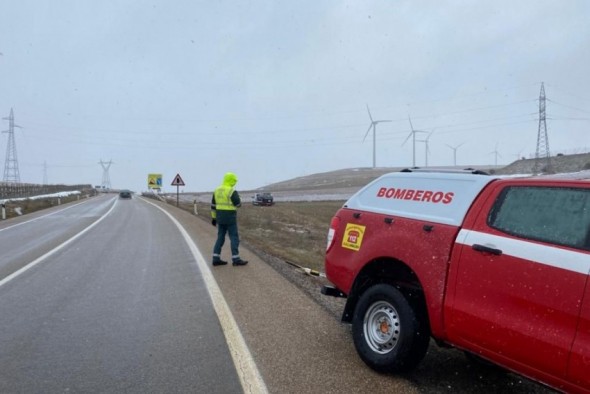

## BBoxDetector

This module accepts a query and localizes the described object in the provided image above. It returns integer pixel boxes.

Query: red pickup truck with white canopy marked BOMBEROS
[322,170,590,392]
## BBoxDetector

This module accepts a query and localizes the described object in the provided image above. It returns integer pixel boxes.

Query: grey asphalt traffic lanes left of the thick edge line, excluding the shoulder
[0,197,241,393]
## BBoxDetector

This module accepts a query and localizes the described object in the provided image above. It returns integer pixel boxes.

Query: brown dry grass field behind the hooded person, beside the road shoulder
[169,200,343,271]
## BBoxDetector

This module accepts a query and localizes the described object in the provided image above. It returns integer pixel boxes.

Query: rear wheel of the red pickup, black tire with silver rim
[352,284,430,373]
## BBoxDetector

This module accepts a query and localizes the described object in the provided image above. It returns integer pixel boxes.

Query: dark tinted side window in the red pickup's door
[488,186,590,250]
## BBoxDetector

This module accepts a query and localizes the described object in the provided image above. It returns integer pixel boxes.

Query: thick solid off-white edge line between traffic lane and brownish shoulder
[141,198,268,394]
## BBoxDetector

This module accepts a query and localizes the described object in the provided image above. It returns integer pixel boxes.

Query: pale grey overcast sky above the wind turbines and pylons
[0,0,590,191]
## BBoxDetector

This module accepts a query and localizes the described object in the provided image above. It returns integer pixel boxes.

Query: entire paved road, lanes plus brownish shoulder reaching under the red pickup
[0,196,549,393]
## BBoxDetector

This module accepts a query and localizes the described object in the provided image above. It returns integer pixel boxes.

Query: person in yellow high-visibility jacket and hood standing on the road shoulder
[211,172,248,266]
